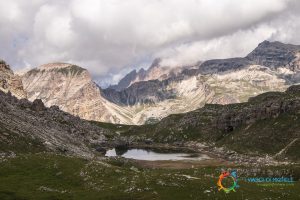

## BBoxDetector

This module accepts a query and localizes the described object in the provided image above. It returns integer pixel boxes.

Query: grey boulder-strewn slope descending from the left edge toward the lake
[0,88,111,158]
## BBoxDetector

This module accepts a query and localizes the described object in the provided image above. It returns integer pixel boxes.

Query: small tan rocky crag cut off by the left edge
[0,60,26,98]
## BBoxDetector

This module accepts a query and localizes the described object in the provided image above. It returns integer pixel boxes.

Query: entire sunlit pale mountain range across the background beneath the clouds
[22,41,300,124]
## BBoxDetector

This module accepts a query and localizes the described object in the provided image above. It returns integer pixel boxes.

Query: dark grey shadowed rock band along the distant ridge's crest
[103,41,300,108]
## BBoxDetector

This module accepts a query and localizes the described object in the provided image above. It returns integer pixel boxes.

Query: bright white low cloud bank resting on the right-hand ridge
[157,25,276,67]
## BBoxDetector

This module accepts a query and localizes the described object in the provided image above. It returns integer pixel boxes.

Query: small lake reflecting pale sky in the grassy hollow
[105,148,210,161]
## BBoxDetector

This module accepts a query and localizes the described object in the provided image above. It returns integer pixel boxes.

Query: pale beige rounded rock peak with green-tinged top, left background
[22,63,131,123]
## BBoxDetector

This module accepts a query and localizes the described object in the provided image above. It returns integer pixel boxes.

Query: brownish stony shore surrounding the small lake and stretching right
[103,140,300,167]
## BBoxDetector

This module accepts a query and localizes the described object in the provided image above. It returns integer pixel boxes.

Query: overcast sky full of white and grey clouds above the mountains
[0,0,300,86]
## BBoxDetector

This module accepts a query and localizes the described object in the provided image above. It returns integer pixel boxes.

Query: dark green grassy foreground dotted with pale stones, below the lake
[0,154,300,200]
